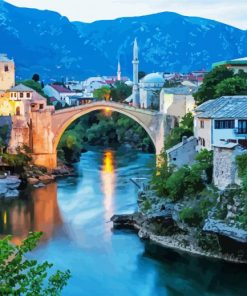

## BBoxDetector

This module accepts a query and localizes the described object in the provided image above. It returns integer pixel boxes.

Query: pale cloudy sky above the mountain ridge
[4,0,247,30]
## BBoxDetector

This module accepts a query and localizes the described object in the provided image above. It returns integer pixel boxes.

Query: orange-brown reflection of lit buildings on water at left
[0,183,63,244]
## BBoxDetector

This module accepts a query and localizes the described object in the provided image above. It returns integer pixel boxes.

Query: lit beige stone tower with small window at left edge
[0,54,15,93]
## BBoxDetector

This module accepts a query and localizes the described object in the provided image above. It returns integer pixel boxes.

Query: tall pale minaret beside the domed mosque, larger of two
[132,38,140,107]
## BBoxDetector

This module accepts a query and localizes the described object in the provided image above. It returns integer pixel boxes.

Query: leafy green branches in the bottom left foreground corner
[0,232,70,296]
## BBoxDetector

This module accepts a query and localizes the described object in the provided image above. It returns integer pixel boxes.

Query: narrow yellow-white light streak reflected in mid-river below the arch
[101,150,116,219]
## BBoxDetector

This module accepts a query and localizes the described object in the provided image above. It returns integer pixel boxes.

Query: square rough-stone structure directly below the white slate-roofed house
[213,142,246,190]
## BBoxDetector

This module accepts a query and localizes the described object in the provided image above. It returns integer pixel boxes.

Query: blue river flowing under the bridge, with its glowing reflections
[0,150,247,296]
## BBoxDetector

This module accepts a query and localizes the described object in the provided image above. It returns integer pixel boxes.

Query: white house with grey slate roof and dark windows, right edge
[194,96,247,150]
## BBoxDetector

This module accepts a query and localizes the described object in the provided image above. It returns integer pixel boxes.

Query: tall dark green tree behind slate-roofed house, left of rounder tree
[194,66,234,105]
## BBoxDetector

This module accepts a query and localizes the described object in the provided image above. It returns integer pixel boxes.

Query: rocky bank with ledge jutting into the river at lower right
[111,193,247,264]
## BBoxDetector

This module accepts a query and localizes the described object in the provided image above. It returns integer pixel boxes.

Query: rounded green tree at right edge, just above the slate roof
[215,76,247,97]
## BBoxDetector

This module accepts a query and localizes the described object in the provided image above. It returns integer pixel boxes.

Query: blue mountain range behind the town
[0,0,247,80]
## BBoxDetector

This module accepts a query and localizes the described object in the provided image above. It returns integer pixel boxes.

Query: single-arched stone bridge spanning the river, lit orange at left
[28,101,171,169]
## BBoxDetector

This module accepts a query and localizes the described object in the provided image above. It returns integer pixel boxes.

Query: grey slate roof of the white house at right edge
[195,95,247,118]
